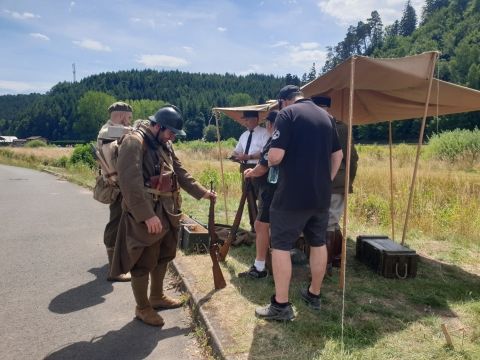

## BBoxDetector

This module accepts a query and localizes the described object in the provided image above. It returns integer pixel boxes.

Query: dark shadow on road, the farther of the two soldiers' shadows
[48,265,113,314]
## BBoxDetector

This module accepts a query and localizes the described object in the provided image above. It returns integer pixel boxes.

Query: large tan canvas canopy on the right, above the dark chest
[302,52,480,124]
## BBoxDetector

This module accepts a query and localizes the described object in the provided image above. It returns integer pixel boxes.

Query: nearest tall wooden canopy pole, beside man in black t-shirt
[340,56,356,289]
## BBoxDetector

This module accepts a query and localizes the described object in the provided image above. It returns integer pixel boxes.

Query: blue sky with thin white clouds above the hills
[0,0,424,95]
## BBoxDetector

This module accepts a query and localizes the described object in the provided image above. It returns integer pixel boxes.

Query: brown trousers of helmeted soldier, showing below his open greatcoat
[130,228,178,277]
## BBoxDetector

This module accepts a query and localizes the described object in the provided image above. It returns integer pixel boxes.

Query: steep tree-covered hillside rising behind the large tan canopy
[322,0,480,141]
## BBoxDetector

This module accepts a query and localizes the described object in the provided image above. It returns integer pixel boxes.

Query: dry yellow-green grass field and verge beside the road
[0,143,480,360]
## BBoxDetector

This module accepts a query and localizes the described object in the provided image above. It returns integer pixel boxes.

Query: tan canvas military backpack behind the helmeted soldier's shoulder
[92,124,143,204]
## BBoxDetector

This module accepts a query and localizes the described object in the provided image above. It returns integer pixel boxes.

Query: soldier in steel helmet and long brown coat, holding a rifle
[111,105,216,326]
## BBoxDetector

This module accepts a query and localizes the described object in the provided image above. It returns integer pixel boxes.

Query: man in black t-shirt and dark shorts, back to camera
[255,85,343,320]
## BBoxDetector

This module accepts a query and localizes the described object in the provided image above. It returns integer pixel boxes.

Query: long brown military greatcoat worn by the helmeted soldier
[110,125,207,276]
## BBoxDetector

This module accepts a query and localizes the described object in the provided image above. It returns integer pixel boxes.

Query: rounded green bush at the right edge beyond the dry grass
[427,128,480,166]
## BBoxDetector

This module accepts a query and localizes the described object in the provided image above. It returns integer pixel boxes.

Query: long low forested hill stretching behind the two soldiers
[0,70,292,140]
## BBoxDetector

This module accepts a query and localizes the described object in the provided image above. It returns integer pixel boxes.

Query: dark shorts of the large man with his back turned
[270,209,328,251]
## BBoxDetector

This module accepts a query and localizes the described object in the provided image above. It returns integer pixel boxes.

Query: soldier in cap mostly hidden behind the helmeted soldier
[97,101,133,281]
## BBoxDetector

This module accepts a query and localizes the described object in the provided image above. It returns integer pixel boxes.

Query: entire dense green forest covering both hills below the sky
[0,0,480,142]
